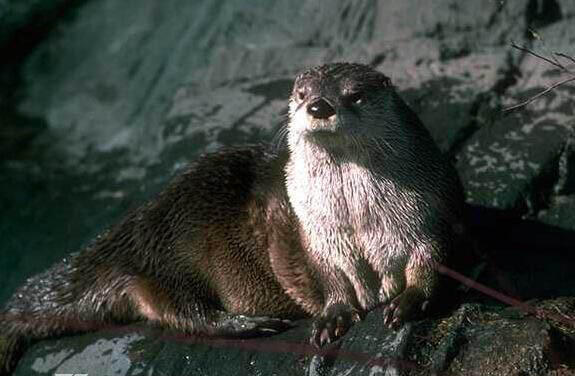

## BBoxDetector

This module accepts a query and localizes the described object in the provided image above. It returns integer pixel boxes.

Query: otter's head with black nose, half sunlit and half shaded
[288,63,391,152]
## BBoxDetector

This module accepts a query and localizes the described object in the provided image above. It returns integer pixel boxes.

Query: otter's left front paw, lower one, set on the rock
[310,303,361,347]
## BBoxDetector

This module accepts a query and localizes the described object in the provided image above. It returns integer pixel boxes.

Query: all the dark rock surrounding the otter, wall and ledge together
[0,0,575,375]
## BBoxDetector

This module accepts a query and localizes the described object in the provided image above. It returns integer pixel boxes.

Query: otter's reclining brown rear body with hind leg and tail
[0,146,322,374]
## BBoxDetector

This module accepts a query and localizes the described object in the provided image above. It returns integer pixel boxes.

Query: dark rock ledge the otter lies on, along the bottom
[14,298,575,376]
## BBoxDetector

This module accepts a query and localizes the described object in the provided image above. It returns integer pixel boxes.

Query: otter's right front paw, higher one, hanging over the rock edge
[383,288,429,329]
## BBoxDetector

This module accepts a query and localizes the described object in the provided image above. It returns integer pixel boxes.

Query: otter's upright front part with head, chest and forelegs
[286,64,463,346]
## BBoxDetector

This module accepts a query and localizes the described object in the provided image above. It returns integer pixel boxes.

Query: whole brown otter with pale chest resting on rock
[0,63,463,374]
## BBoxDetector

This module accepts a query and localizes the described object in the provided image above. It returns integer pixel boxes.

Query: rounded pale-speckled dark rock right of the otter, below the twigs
[457,103,569,215]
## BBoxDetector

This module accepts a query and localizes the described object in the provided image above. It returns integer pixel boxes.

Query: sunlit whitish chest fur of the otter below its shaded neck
[287,144,426,309]
